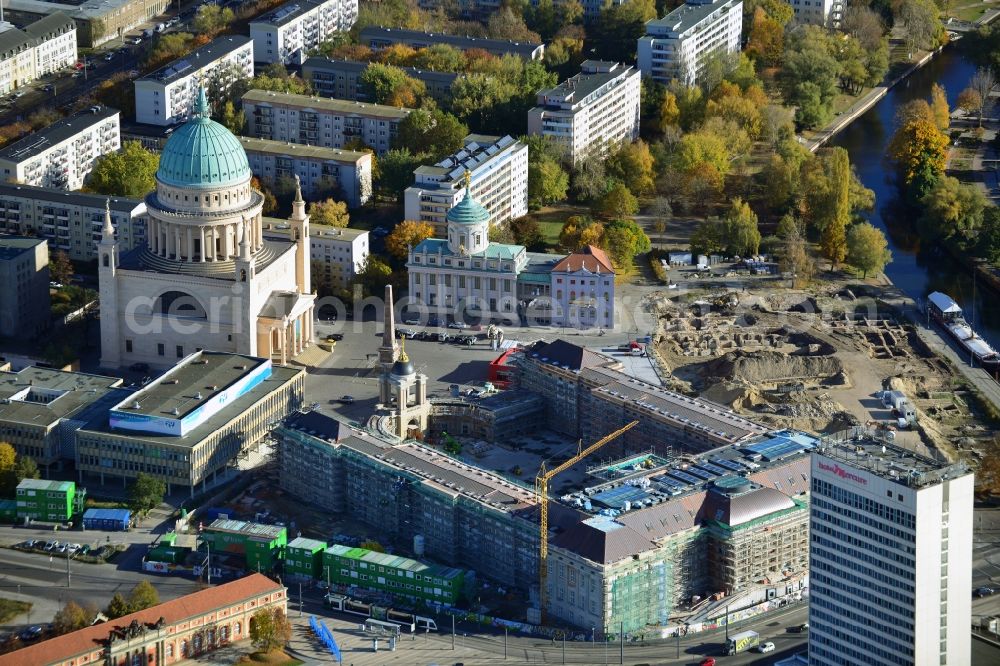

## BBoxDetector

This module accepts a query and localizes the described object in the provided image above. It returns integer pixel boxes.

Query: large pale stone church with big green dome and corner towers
[98,88,315,369]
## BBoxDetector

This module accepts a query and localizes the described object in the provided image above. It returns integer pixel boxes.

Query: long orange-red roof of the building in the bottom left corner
[0,573,285,666]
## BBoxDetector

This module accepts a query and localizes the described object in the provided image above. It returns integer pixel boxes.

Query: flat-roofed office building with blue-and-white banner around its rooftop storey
[76,350,305,495]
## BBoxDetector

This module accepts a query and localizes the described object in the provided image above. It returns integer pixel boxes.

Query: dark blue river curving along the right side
[829,45,1000,348]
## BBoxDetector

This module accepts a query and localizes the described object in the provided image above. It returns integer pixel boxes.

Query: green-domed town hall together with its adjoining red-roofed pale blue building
[406,172,615,329]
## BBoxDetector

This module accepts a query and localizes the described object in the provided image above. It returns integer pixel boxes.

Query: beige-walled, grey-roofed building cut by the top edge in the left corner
[3,0,170,47]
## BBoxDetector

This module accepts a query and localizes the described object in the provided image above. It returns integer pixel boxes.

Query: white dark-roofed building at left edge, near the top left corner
[0,12,76,95]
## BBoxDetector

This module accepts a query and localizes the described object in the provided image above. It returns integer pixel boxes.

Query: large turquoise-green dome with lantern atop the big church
[156,88,251,188]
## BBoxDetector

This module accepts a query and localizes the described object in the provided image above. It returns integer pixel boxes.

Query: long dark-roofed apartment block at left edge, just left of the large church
[0,183,146,261]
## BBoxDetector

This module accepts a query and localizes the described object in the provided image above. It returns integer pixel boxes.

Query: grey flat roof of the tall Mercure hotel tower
[816,426,971,488]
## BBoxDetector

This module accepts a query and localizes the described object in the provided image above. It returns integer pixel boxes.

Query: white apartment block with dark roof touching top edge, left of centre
[250,0,358,65]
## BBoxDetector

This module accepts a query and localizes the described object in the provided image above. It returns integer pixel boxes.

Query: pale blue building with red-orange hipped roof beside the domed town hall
[550,245,615,328]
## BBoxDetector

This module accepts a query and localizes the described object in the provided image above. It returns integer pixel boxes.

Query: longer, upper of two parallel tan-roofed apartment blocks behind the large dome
[243,90,411,154]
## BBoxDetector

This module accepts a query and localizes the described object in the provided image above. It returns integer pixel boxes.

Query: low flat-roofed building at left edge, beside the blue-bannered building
[0,366,130,476]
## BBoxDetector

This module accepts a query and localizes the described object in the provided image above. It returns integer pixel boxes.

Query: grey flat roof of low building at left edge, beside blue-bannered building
[0,366,122,426]
